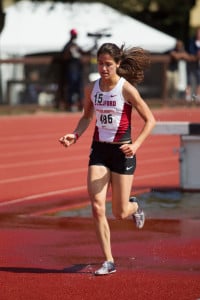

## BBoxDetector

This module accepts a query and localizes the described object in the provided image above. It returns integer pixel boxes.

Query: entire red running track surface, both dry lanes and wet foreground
[0,108,200,300]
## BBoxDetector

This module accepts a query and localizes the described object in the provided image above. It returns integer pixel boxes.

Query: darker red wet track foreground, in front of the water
[0,217,200,300]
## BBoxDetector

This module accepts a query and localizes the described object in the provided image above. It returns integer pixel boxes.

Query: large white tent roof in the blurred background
[0,1,175,57]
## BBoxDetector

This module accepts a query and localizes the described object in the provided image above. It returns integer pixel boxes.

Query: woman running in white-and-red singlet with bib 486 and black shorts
[59,43,155,275]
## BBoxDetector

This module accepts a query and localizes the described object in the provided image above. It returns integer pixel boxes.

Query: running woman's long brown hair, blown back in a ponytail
[97,43,150,85]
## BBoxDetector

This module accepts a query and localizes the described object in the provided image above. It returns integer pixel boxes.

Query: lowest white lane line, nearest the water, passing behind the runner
[0,171,178,207]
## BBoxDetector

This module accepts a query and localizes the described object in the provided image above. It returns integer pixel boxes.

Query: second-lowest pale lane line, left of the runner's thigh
[0,168,87,184]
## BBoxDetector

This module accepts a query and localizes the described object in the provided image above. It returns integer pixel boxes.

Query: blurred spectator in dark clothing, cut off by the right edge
[186,27,200,103]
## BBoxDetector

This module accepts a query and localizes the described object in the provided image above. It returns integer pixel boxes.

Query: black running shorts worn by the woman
[89,141,136,175]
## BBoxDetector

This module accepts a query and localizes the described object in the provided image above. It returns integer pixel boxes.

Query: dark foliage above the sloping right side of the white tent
[66,0,195,42]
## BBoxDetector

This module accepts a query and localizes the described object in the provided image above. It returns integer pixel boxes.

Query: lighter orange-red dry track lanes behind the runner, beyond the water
[0,108,200,211]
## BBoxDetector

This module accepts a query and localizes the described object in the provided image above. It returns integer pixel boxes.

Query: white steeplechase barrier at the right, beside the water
[152,121,200,191]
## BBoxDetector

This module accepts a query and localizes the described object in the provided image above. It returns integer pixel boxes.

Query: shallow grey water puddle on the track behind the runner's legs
[55,190,200,219]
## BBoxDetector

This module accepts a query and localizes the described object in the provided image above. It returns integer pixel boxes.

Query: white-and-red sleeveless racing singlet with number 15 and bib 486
[91,77,132,142]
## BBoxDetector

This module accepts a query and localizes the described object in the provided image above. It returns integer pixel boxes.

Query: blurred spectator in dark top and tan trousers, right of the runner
[167,40,190,99]
